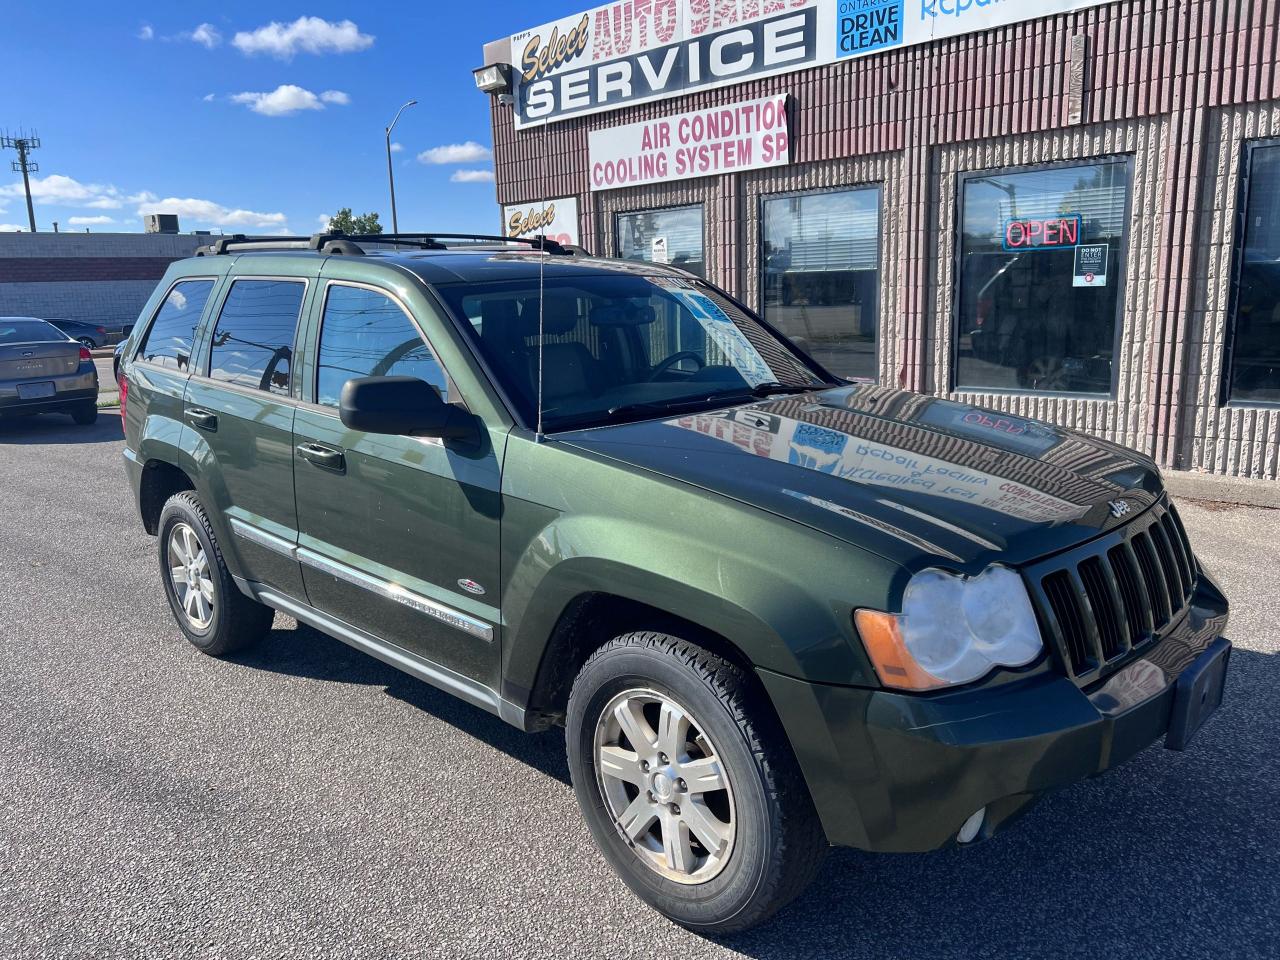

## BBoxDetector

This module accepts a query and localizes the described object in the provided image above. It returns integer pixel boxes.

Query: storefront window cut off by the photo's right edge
[1228,143,1280,403]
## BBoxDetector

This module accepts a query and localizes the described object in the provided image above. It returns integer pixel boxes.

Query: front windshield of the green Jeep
[439,274,828,431]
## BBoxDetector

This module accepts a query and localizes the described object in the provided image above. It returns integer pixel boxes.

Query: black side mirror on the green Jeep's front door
[338,376,472,439]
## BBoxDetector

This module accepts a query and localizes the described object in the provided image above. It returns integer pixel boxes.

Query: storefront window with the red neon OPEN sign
[955,160,1129,394]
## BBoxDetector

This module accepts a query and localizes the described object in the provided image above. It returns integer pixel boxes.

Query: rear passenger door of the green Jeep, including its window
[183,274,312,598]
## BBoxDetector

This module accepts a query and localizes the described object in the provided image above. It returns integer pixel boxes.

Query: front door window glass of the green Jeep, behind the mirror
[316,284,448,407]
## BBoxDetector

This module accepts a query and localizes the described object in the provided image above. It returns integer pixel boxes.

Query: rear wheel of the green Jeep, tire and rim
[156,490,275,657]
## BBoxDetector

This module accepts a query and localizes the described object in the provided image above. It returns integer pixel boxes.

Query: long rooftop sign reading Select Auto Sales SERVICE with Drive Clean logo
[511,0,1106,129]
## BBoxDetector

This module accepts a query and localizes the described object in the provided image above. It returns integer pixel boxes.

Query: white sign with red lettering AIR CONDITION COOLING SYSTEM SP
[588,95,791,189]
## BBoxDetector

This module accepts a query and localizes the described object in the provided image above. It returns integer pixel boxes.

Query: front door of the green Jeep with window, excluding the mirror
[293,280,503,686]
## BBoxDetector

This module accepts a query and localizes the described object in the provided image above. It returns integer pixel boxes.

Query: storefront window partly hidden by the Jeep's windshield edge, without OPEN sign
[760,187,879,380]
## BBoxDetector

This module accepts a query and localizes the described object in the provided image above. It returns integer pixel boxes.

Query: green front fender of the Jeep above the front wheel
[503,444,897,694]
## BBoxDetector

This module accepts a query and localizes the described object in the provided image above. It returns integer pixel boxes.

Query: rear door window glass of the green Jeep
[209,280,306,394]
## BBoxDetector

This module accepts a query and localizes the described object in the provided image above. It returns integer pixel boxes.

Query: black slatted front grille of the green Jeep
[1029,503,1197,681]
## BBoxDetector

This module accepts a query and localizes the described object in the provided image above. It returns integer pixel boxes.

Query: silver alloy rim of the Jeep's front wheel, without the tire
[595,689,736,883]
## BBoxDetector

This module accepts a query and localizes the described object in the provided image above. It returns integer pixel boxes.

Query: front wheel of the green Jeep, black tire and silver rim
[566,632,827,934]
